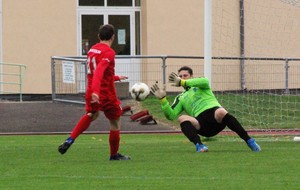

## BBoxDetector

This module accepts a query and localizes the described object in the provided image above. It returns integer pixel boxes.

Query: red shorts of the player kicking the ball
[85,92,123,120]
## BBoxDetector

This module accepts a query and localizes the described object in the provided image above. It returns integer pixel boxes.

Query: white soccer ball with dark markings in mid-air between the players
[130,82,150,101]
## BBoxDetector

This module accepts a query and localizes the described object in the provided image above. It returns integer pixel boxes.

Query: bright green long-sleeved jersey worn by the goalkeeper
[161,78,221,120]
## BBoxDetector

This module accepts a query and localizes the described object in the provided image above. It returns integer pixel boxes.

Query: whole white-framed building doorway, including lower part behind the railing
[77,0,141,91]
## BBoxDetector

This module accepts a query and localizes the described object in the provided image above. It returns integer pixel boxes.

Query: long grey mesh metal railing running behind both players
[51,55,300,103]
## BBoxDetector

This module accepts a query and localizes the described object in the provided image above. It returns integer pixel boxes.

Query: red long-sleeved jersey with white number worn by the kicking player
[86,43,120,102]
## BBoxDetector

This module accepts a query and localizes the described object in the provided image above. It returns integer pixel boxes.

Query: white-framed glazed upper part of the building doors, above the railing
[78,0,141,55]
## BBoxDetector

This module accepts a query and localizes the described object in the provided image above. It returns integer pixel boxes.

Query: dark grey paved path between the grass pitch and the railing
[0,101,177,134]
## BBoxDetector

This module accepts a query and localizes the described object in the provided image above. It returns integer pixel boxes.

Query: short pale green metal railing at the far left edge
[0,63,26,102]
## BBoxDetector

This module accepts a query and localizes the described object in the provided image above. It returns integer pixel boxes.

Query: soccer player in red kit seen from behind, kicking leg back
[58,24,130,160]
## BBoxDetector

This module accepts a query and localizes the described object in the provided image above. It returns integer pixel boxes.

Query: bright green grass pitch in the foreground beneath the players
[0,134,300,190]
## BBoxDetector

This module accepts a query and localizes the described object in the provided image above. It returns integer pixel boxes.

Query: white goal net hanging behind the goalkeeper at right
[212,0,300,133]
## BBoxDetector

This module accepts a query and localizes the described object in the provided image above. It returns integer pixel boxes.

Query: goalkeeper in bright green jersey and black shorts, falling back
[151,66,261,152]
